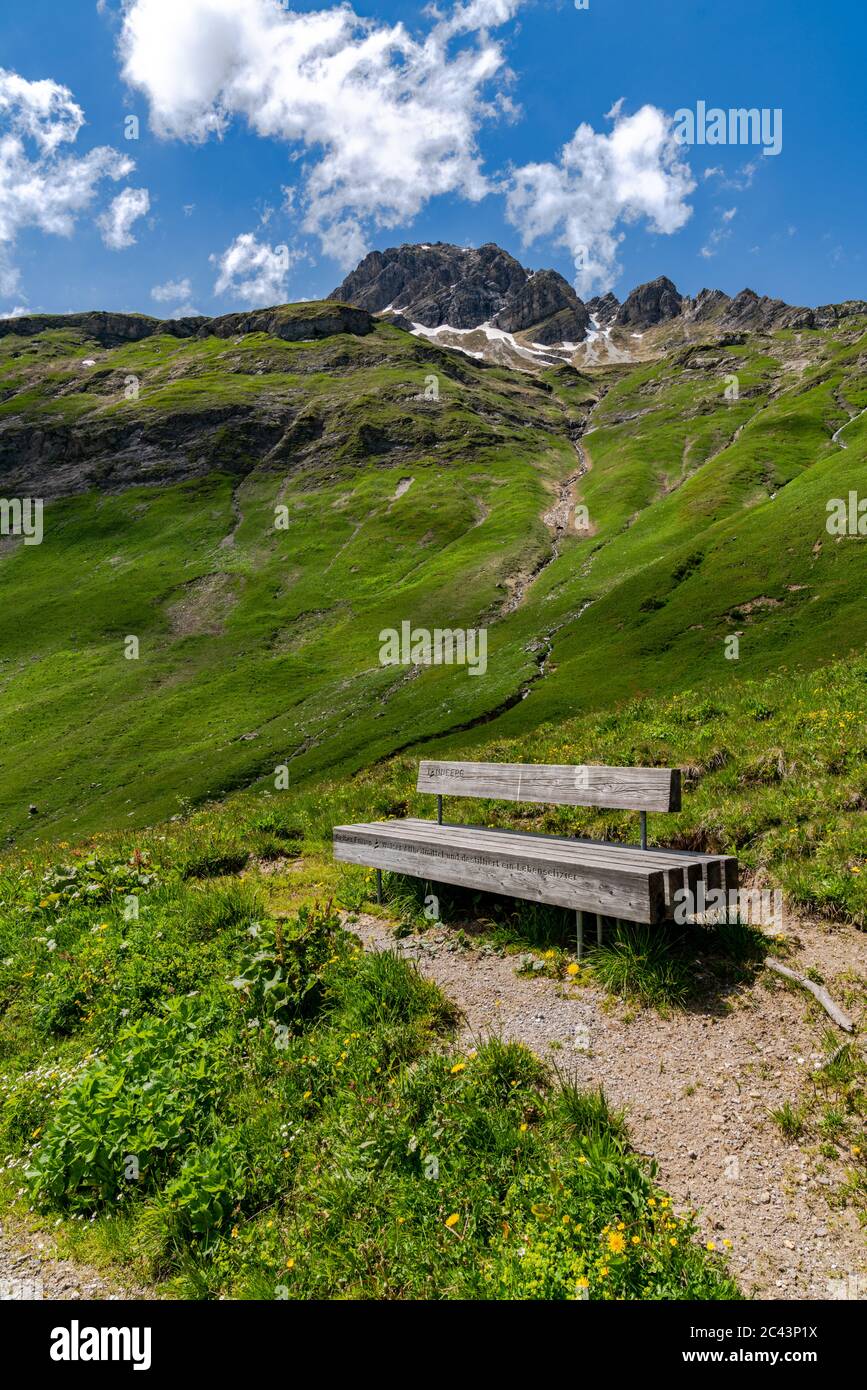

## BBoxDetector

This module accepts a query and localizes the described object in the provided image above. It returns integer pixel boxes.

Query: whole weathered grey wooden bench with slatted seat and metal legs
[333,762,738,959]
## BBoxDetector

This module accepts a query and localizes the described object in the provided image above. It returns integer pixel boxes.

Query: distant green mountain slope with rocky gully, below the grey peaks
[0,306,867,840]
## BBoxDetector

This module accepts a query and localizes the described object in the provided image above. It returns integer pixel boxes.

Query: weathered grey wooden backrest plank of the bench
[417,762,681,810]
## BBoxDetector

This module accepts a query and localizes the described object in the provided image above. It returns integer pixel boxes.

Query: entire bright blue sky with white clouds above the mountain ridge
[0,0,867,316]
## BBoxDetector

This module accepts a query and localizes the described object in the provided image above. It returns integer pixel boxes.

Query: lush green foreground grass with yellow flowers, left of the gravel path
[0,823,738,1300]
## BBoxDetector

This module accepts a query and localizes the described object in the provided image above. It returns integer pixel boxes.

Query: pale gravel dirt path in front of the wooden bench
[347,915,867,1298]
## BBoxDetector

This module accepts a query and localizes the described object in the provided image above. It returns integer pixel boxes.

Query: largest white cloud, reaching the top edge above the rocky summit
[119,0,518,260]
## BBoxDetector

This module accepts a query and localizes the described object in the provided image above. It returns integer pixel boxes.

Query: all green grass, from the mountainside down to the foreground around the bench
[0,306,867,1298]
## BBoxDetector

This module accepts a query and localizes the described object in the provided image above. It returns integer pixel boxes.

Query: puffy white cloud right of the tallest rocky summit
[506,101,695,297]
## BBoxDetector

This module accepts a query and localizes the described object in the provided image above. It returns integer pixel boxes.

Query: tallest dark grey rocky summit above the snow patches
[331,242,589,345]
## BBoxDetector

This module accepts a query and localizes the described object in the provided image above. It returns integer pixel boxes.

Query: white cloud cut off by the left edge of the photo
[0,68,135,284]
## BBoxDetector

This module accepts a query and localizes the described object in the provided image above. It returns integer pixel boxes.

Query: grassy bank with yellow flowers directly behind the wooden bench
[155,653,867,928]
